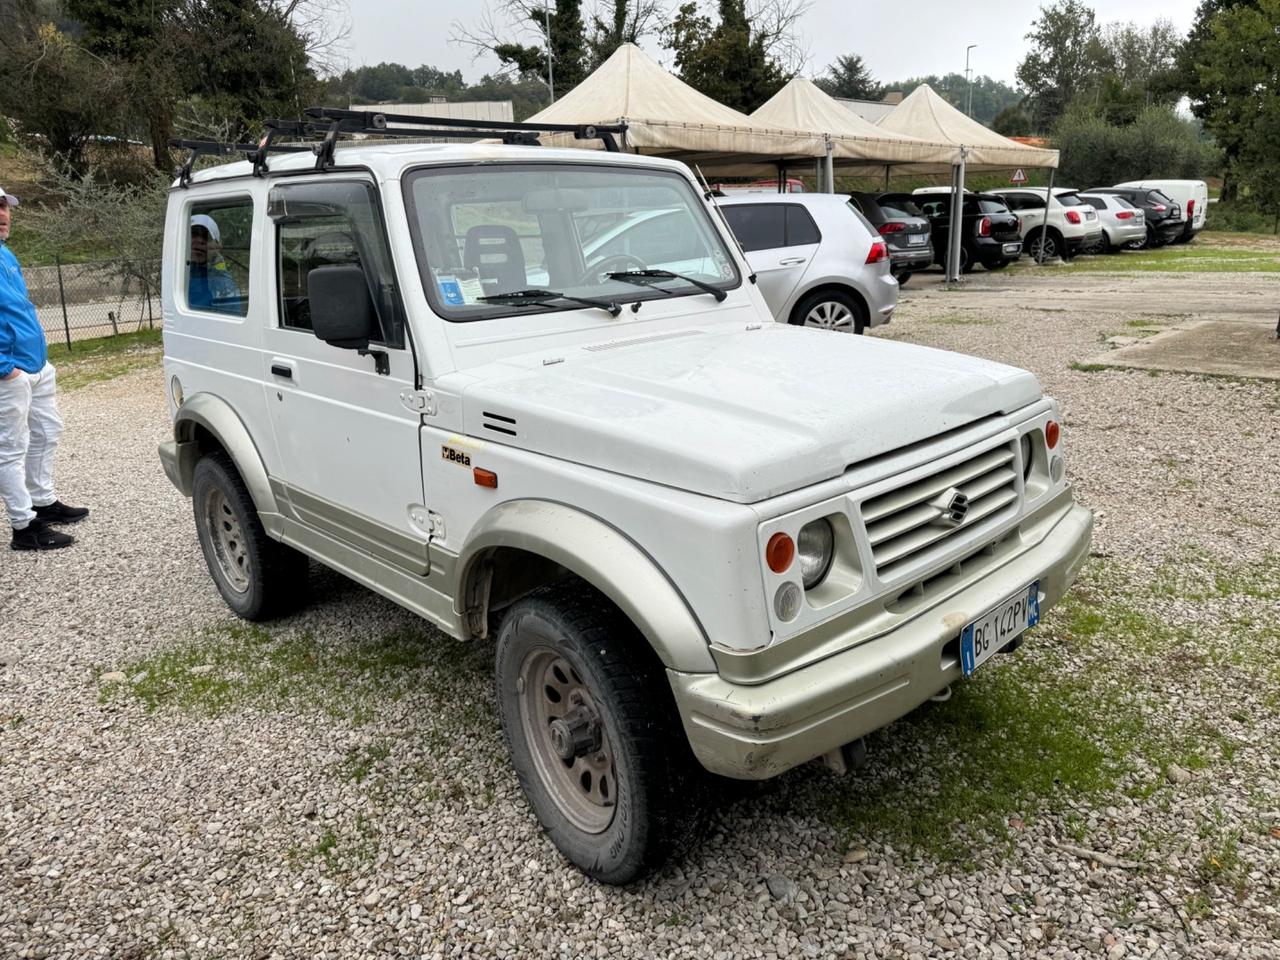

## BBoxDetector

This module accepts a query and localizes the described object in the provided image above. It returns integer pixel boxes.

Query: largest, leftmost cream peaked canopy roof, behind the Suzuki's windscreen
[529,44,827,175]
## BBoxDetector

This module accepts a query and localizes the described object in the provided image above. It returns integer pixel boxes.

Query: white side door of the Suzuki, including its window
[261,174,430,576]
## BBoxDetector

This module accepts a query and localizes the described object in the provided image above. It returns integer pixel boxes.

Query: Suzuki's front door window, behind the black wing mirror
[268,180,404,347]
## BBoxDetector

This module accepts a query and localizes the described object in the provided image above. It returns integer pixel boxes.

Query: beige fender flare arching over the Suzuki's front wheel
[453,500,716,673]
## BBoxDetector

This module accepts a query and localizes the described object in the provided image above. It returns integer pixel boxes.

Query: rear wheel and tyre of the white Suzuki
[191,453,307,621]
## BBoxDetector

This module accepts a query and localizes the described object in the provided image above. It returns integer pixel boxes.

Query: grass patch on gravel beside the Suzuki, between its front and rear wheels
[101,623,493,727]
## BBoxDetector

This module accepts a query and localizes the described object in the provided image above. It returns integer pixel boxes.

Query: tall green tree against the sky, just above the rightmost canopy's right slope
[1018,0,1110,129]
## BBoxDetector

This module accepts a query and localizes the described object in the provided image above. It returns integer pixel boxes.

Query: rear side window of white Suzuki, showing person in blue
[186,197,253,316]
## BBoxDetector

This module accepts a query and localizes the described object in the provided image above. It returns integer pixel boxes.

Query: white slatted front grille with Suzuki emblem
[861,444,1018,581]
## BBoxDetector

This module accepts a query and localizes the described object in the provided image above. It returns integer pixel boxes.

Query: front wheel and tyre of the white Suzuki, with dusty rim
[494,582,708,884]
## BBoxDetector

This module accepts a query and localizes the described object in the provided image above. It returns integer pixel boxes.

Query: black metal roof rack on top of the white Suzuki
[169,106,627,187]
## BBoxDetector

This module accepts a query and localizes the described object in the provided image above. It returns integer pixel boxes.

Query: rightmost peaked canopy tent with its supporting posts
[877,83,1057,282]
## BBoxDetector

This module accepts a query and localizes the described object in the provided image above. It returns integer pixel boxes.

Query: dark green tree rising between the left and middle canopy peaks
[663,0,794,113]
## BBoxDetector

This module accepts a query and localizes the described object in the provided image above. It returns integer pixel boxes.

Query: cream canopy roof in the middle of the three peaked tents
[751,77,960,169]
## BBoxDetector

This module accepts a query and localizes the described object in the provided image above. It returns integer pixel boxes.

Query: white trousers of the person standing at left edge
[0,364,63,530]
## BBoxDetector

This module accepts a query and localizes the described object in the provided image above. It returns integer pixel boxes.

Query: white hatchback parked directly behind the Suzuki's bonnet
[719,193,897,333]
